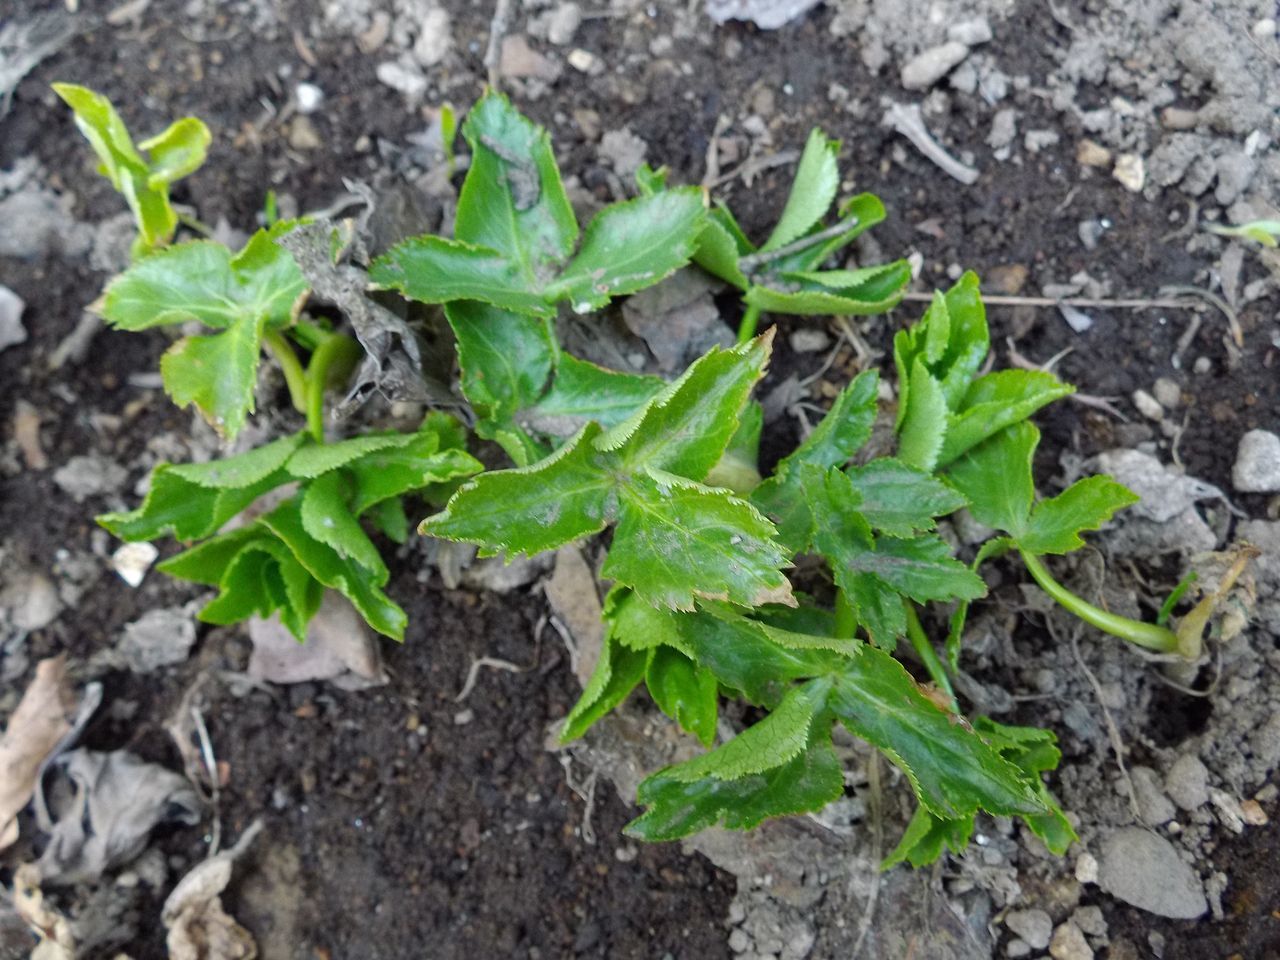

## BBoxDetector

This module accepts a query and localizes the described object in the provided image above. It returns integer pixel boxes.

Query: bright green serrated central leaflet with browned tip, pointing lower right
[600,471,791,611]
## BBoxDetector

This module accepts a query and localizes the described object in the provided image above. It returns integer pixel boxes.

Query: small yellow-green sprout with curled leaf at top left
[54,83,211,259]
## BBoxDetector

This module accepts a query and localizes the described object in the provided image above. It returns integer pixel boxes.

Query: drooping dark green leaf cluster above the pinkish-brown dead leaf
[97,413,483,641]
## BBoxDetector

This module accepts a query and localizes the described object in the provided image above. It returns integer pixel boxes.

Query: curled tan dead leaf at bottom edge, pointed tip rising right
[160,820,262,960]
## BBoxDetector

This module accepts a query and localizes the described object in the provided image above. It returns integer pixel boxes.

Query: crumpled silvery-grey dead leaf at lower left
[40,749,201,886]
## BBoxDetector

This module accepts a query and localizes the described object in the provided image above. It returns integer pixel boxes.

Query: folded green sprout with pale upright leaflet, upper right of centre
[694,129,911,342]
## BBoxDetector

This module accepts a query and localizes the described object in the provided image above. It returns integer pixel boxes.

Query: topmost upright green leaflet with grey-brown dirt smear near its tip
[453,91,577,281]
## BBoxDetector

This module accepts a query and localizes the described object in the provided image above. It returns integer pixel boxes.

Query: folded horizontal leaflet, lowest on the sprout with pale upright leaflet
[742,260,911,316]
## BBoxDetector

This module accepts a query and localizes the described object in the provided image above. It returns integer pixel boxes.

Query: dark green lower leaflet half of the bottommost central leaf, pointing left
[623,722,844,842]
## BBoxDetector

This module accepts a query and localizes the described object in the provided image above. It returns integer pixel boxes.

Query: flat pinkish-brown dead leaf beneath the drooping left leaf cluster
[247,590,387,690]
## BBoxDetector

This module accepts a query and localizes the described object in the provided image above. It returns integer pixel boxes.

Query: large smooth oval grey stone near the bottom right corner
[1095,827,1208,921]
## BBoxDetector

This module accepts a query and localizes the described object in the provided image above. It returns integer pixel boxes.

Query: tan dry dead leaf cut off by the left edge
[0,657,76,850]
